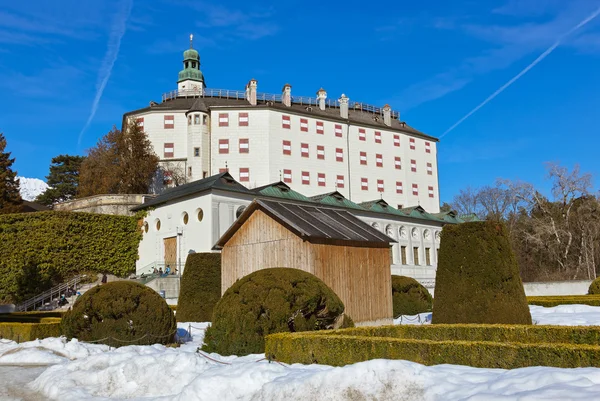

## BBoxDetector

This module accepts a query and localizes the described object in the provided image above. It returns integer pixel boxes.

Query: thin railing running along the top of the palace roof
[162,89,400,119]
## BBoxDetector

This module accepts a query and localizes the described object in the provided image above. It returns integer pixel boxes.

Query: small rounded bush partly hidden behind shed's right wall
[392,276,432,317]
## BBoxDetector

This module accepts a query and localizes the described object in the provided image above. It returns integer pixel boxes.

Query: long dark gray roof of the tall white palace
[123,97,438,142]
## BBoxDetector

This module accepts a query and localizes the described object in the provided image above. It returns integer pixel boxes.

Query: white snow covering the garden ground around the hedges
[0,305,600,401]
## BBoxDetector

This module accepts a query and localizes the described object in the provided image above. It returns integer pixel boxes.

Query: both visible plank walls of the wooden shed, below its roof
[221,210,392,324]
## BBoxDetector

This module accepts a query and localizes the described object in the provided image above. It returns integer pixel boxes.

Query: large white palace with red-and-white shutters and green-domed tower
[123,36,439,213]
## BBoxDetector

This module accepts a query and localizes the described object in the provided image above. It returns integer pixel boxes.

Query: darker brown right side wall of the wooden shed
[312,244,393,324]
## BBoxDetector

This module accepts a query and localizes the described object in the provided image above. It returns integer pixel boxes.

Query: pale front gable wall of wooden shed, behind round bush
[221,210,314,295]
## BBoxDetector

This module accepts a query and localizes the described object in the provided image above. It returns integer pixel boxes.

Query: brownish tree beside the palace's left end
[78,122,159,197]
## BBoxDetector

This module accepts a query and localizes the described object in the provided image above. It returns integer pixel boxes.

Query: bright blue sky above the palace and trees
[0,0,600,201]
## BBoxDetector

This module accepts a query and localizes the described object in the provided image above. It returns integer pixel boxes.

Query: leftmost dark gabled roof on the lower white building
[131,173,252,211]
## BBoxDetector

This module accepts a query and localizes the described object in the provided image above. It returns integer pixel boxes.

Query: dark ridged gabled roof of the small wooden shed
[213,199,395,250]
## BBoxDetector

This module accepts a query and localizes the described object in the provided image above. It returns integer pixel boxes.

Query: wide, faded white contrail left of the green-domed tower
[77,0,133,146]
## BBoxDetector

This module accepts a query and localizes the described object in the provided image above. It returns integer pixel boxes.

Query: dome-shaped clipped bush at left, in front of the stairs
[62,281,176,346]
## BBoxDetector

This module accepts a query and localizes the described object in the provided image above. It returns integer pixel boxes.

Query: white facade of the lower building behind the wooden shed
[136,186,443,288]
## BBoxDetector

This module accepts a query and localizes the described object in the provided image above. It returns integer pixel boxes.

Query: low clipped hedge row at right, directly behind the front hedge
[300,324,600,345]
